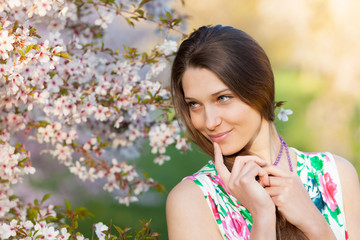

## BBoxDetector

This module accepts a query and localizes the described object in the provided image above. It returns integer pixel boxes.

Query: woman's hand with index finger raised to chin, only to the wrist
[214,143,275,215]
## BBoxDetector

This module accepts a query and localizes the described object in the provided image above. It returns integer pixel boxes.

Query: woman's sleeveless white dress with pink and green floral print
[185,148,348,240]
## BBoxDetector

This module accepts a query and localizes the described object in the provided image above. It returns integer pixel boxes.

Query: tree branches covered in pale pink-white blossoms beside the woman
[0,0,188,239]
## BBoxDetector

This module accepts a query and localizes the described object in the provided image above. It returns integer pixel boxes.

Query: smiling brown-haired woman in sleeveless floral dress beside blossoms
[166,25,360,240]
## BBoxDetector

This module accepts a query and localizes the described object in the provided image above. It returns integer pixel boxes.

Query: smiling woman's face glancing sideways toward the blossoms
[182,68,262,155]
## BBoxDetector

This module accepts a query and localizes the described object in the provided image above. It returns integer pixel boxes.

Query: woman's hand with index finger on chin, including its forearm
[214,143,276,240]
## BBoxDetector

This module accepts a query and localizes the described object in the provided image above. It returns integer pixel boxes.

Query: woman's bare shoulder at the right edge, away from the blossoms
[334,155,360,239]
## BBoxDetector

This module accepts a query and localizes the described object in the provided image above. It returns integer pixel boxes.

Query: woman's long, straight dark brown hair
[171,25,306,239]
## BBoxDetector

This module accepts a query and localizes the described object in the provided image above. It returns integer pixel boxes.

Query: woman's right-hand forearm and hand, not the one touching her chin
[263,165,334,239]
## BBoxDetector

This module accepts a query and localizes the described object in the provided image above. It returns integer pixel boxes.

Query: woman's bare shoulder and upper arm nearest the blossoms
[166,179,221,240]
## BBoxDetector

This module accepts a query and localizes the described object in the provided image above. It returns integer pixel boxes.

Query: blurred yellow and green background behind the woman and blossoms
[17,0,360,239]
